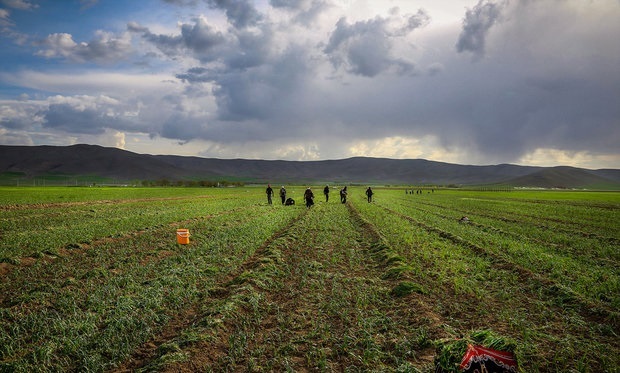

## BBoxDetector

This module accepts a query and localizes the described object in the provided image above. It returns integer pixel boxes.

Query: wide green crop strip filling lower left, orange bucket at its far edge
[0,190,299,371]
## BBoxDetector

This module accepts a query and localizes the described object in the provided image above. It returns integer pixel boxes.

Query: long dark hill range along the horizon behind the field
[0,145,620,189]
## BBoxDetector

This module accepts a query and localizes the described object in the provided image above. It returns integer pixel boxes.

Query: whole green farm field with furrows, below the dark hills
[0,187,620,372]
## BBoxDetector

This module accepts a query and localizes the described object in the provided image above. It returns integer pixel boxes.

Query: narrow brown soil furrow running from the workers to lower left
[109,211,307,373]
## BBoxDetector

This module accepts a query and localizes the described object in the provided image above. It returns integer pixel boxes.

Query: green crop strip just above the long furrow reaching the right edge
[390,190,620,309]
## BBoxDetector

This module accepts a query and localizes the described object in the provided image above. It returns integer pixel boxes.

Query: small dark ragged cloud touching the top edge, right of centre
[456,0,507,56]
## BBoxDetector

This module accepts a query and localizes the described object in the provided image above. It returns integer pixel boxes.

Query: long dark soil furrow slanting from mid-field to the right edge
[380,202,620,333]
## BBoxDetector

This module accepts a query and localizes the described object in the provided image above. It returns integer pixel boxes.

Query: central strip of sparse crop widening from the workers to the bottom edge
[119,199,444,371]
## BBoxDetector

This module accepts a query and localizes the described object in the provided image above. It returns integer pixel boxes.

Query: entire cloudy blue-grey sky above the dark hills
[0,0,620,168]
